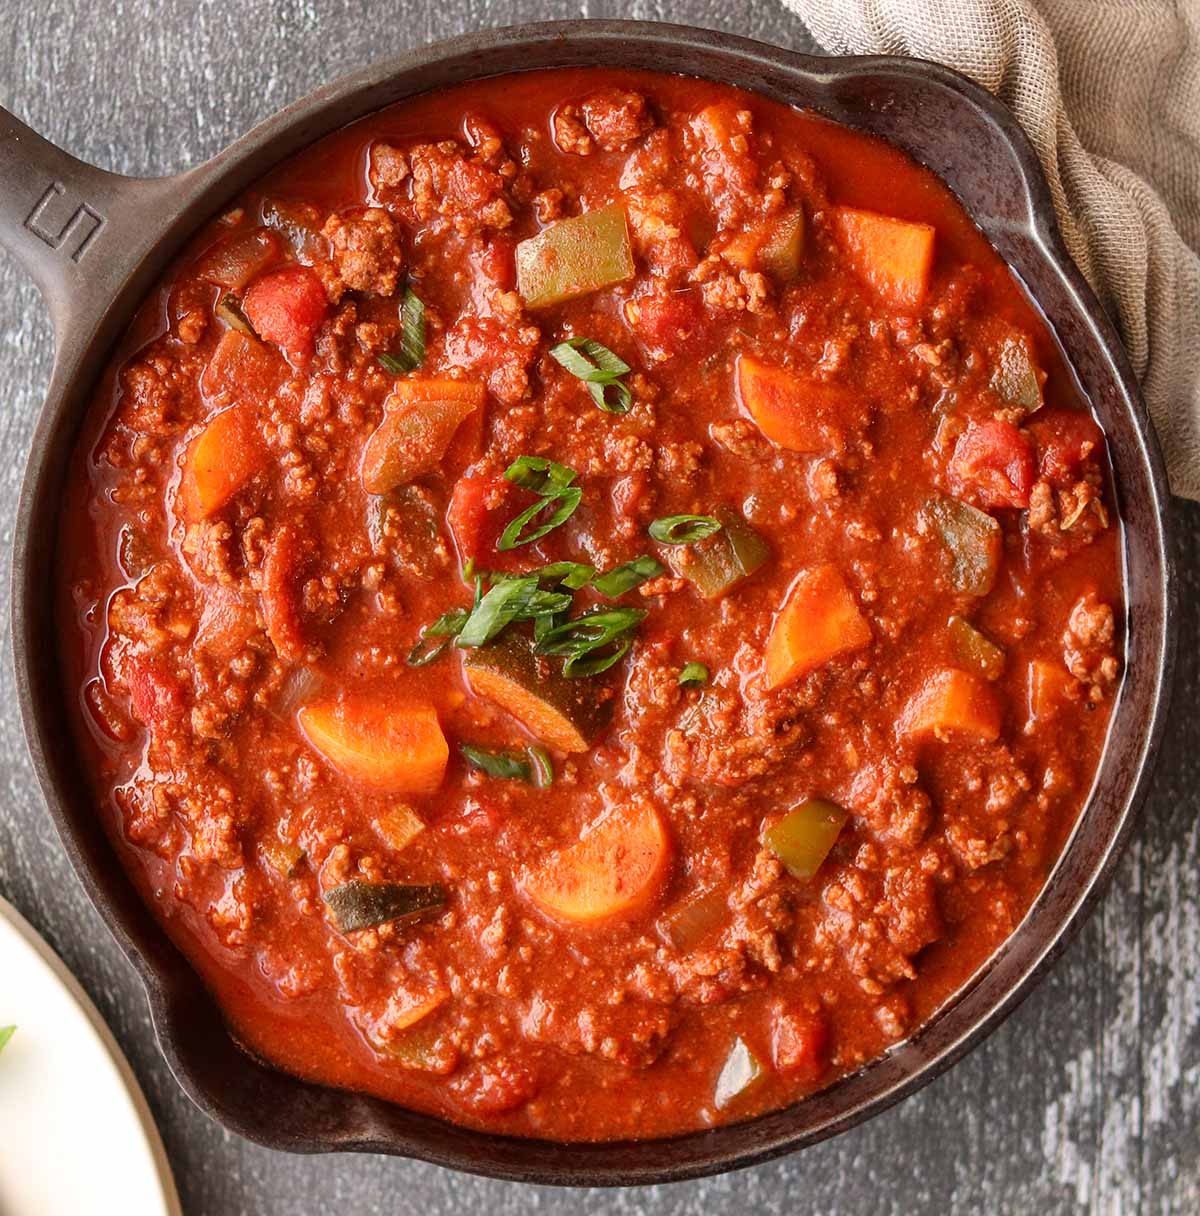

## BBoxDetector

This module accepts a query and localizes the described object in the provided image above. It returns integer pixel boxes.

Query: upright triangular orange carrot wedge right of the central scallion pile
[764,564,872,688]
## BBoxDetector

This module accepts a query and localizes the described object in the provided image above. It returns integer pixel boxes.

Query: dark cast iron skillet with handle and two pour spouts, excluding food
[0,14,1174,1186]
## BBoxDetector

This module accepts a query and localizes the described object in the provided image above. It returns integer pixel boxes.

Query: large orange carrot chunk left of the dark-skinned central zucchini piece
[298,698,450,794]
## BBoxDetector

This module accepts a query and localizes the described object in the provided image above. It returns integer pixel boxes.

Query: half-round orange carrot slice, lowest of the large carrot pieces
[524,801,670,924]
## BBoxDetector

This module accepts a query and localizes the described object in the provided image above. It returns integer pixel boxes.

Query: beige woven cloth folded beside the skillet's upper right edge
[784,0,1200,500]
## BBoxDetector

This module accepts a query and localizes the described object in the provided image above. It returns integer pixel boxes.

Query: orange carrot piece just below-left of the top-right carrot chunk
[737,355,861,452]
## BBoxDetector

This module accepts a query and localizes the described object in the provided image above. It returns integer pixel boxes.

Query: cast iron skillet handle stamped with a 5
[0,107,167,351]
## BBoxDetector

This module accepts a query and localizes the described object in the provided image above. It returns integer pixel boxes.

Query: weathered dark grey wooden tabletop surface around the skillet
[0,0,1200,1216]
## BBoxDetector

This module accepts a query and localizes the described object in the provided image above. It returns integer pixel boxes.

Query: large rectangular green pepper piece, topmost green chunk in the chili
[517,203,633,308]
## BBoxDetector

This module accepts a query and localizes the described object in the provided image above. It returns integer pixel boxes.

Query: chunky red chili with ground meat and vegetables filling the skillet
[60,71,1122,1139]
